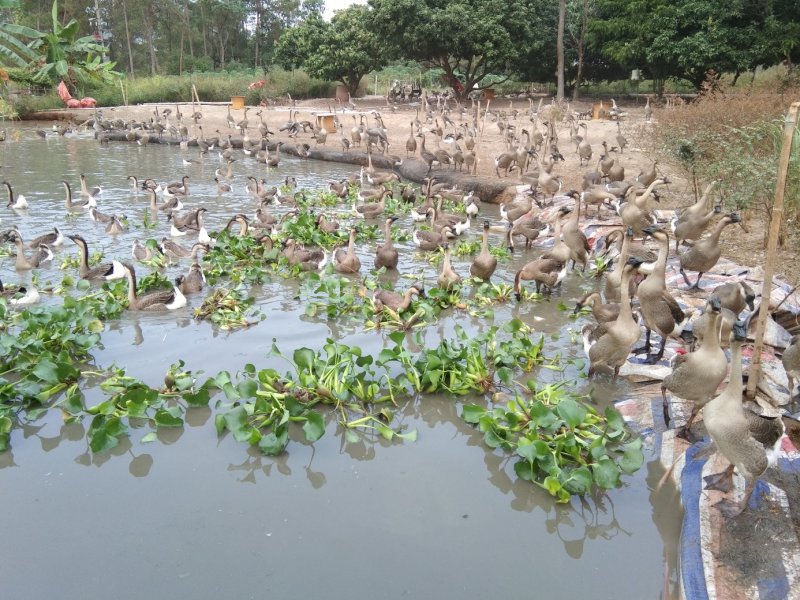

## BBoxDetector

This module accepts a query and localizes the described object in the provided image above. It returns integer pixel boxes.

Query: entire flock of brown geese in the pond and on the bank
[0,96,800,515]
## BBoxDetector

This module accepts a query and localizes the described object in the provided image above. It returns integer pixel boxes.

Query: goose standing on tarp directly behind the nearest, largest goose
[661,296,728,437]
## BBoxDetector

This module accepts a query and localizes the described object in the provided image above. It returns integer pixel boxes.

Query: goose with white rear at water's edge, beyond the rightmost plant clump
[581,257,642,379]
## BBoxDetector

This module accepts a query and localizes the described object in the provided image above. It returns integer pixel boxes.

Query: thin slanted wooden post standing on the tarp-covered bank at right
[745,102,800,399]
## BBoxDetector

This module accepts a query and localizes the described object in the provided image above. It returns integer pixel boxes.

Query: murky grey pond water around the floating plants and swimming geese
[0,126,681,599]
